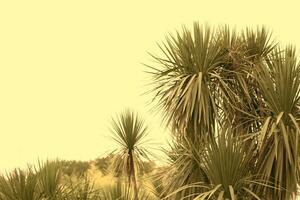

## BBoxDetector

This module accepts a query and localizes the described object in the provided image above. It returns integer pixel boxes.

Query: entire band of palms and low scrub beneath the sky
[0,23,300,200]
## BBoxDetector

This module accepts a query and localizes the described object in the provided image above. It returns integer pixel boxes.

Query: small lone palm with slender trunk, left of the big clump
[111,110,149,200]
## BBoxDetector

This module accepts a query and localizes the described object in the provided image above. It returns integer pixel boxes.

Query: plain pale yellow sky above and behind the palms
[0,0,300,171]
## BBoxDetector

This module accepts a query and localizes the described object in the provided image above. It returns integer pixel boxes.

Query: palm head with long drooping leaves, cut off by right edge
[256,47,300,199]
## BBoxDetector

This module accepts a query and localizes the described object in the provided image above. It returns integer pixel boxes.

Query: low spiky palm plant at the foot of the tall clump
[196,131,270,200]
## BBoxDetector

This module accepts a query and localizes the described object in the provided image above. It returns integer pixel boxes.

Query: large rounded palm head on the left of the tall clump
[151,23,224,138]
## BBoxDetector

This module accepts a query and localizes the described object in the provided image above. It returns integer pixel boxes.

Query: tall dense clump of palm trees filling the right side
[148,23,300,200]
